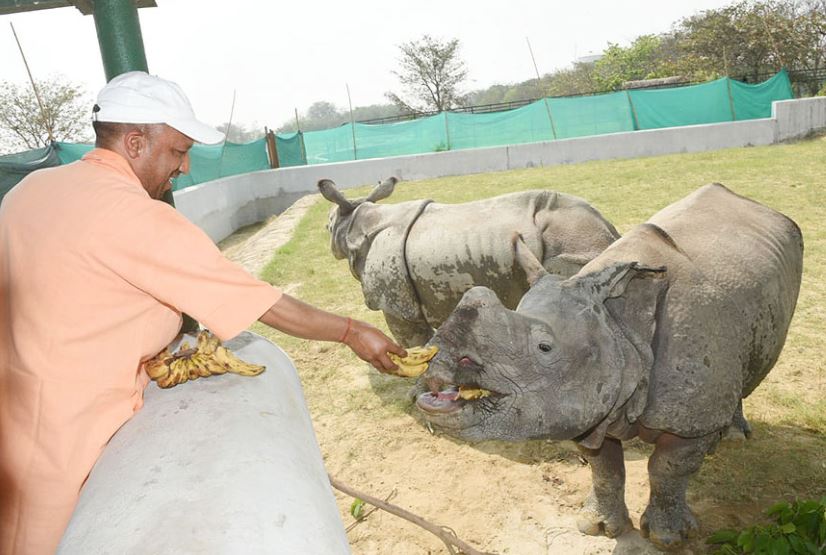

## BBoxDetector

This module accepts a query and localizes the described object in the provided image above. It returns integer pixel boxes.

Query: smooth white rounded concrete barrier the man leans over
[58,332,350,555]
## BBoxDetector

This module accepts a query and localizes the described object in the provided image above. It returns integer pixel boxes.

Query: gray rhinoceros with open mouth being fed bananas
[417,184,803,549]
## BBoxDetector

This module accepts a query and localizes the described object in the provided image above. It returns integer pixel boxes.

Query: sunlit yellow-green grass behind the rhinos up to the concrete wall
[263,137,826,433]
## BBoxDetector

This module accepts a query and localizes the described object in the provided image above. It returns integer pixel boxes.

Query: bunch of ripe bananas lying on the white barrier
[144,330,265,388]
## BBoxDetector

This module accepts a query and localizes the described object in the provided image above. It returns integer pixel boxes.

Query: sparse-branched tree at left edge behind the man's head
[0,77,92,153]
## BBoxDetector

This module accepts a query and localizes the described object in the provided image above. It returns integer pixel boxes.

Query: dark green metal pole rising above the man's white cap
[95,0,148,81]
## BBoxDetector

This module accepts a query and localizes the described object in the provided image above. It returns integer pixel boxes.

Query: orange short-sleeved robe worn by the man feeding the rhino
[0,149,281,555]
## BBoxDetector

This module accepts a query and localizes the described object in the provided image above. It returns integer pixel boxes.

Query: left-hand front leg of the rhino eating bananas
[577,437,633,538]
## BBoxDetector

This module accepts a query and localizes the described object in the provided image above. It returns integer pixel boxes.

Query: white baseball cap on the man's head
[92,71,224,144]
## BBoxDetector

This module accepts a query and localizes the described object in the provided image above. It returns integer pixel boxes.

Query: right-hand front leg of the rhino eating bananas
[640,433,720,550]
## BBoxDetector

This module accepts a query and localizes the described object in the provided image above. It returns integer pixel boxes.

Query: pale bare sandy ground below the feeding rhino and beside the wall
[222,200,728,555]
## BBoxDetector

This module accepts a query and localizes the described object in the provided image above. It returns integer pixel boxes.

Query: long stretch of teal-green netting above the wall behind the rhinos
[304,70,793,164]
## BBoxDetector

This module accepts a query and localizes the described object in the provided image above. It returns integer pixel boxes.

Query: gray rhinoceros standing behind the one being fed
[318,177,618,347]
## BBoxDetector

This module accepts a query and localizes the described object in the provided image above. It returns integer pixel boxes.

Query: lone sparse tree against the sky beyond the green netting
[385,35,468,112]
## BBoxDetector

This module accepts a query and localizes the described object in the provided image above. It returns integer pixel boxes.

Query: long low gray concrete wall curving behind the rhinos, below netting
[175,97,826,241]
